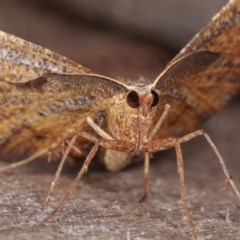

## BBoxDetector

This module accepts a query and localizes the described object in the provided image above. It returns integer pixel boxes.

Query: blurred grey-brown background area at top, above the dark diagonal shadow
[67,0,227,48]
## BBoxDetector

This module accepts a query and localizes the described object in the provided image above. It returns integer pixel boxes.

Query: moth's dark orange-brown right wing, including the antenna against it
[154,0,240,137]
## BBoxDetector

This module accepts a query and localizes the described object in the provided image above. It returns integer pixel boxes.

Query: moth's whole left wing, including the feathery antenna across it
[0,31,129,158]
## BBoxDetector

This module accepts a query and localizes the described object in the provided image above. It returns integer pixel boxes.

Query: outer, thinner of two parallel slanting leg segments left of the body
[44,134,78,207]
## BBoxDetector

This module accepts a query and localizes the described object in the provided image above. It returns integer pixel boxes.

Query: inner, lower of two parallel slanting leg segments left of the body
[44,144,99,221]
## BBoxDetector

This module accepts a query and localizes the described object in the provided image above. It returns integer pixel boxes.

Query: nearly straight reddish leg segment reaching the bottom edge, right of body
[175,140,197,239]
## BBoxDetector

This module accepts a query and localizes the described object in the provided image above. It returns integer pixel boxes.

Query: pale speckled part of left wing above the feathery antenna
[0,31,90,84]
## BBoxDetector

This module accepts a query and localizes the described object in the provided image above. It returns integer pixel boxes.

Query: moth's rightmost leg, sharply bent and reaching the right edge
[179,130,240,201]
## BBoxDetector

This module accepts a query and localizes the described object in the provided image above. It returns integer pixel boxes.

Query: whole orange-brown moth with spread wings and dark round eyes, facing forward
[0,0,240,238]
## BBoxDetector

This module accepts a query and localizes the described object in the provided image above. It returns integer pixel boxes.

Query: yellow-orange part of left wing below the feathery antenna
[0,82,95,156]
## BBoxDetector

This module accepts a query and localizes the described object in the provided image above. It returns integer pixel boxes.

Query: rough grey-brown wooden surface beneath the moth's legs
[0,101,240,239]
